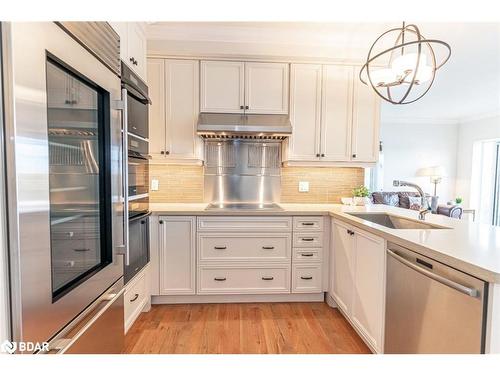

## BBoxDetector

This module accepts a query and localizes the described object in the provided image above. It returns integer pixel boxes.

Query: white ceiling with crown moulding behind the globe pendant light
[147,22,500,123]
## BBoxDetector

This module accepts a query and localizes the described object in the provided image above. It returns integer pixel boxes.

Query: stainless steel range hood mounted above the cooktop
[198,113,292,139]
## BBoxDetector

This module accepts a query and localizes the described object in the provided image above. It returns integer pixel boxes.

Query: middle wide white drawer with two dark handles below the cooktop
[198,233,292,262]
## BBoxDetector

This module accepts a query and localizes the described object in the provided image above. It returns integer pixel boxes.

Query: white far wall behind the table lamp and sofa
[380,119,458,204]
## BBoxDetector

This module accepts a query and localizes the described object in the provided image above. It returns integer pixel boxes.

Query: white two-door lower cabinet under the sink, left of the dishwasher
[330,221,385,353]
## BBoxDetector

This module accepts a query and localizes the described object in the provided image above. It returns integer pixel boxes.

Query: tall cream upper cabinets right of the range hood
[284,64,380,165]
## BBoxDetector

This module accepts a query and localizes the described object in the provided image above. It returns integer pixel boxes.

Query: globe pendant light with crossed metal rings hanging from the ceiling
[359,22,451,104]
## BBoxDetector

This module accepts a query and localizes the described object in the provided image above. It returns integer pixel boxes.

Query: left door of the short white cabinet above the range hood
[200,61,245,113]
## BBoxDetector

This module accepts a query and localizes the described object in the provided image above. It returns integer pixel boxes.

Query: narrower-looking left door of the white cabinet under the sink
[332,222,354,315]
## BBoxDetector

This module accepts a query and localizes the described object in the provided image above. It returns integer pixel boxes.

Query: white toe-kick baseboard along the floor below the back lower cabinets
[151,293,325,305]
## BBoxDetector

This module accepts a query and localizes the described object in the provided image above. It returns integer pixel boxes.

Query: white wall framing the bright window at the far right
[456,116,500,206]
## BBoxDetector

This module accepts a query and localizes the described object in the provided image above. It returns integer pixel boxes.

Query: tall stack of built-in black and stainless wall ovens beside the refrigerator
[122,63,151,283]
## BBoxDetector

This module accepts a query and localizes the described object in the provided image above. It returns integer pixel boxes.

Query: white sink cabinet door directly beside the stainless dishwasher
[351,231,385,352]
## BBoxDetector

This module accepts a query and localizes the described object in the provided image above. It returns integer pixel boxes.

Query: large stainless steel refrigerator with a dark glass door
[1,22,128,353]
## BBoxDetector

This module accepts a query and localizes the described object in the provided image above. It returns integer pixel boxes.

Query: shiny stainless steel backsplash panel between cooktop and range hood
[204,140,281,203]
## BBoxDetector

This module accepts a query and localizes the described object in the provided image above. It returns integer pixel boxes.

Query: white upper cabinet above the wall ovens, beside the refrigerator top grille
[110,22,146,81]
